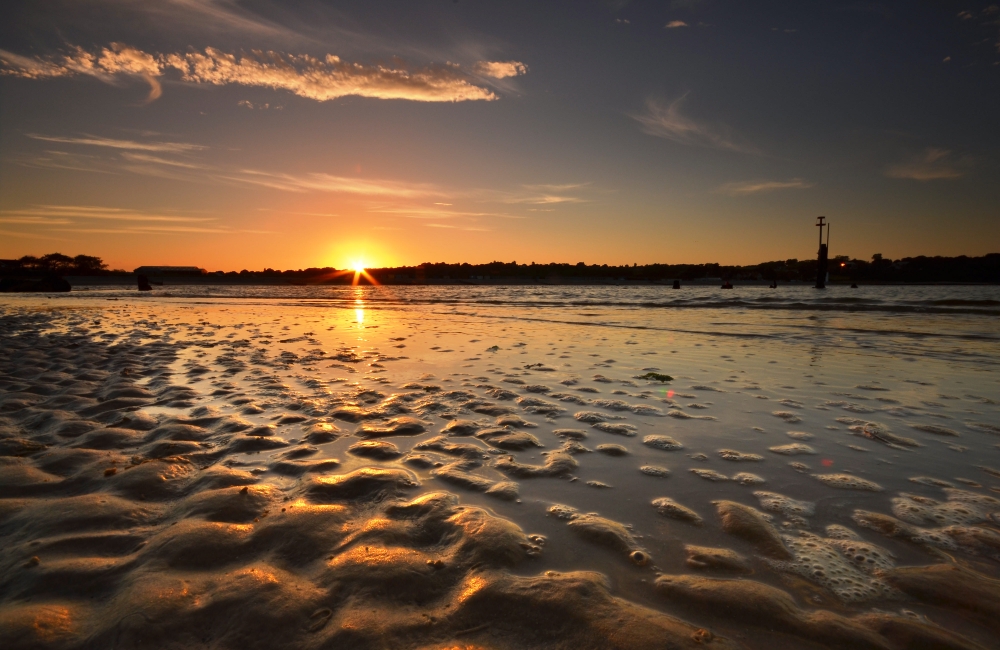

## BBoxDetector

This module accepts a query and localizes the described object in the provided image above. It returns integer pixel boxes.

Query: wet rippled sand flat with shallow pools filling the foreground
[0,290,1000,648]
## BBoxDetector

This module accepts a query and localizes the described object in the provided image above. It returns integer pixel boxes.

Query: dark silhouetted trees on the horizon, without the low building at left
[0,253,1000,284]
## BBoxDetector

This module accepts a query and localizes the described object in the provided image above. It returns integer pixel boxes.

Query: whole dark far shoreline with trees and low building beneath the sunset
[7,253,1000,287]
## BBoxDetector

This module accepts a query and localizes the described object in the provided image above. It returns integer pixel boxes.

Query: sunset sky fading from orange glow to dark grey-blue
[0,0,1000,271]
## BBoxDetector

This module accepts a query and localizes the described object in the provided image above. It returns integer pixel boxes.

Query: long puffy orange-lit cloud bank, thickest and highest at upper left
[0,43,528,102]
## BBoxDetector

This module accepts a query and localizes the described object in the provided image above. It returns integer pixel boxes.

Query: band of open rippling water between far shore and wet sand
[50,286,1000,366]
